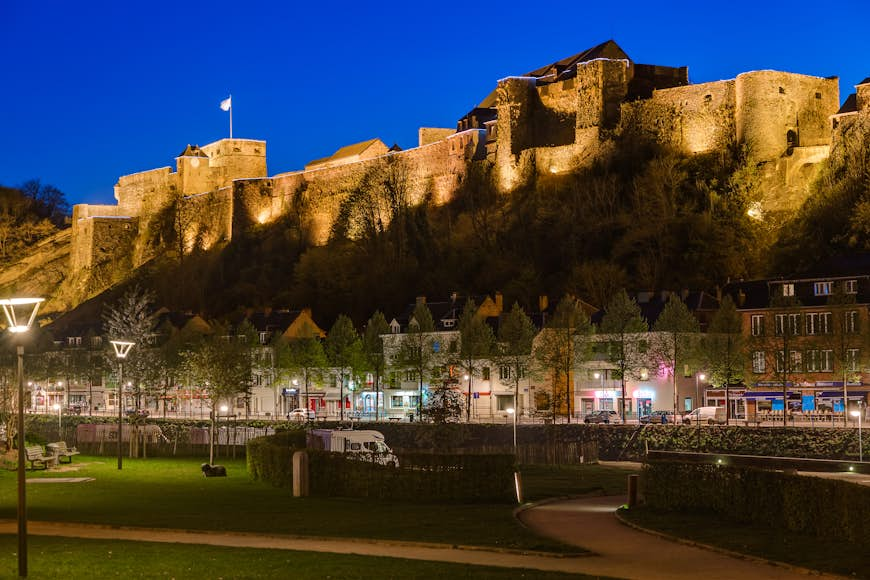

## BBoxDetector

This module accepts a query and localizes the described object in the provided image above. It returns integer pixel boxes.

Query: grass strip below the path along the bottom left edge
[0,535,600,580]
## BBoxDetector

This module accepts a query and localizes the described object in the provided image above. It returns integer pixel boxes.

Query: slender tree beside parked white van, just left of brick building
[703,296,746,424]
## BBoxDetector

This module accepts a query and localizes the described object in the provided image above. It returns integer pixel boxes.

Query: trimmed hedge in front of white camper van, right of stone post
[308,450,516,503]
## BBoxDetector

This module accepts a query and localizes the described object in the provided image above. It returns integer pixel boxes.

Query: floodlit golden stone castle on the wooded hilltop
[70,41,870,294]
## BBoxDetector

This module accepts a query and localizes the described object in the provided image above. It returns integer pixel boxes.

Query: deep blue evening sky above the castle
[0,0,870,203]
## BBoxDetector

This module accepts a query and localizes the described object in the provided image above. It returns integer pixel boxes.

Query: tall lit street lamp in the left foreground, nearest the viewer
[0,298,44,578]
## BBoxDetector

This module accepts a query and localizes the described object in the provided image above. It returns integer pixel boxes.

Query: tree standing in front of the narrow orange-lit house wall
[535,295,592,423]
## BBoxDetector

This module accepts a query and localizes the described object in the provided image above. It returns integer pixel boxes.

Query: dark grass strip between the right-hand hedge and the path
[621,508,870,578]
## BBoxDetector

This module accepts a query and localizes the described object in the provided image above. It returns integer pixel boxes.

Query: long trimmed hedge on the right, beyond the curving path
[641,462,870,550]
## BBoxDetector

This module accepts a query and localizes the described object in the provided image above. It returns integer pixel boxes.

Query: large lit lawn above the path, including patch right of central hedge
[0,456,625,552]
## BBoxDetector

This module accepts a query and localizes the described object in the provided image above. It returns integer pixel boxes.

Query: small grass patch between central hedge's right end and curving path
[520,465,639,501]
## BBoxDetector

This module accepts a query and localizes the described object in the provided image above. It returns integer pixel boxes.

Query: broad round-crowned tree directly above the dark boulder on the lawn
[184,335,253,463]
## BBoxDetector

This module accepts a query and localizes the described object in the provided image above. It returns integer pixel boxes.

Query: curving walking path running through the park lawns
[0,496,836,580]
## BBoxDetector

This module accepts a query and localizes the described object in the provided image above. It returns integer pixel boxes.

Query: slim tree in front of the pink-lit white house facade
[651,294,701,417]
